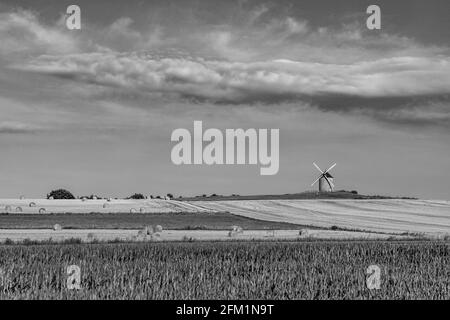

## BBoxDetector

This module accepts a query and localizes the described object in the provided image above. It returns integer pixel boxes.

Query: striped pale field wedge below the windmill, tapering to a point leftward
[193,199,450,235]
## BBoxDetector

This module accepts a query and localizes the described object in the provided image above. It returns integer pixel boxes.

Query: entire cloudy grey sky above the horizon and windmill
[0,0,450,200]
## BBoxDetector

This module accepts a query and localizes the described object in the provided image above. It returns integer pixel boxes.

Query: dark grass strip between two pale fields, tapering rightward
[0,212,302,230]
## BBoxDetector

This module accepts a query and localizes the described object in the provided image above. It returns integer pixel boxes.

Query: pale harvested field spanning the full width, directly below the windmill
[0,199,450,237]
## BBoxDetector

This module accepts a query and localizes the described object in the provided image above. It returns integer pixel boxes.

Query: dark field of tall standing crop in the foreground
[0,241,450,300]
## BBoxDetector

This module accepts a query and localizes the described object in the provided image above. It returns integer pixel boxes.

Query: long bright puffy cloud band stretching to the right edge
[17,53,450,103]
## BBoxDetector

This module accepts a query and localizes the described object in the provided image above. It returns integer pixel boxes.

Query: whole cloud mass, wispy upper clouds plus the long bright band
[0,6,450,131]
